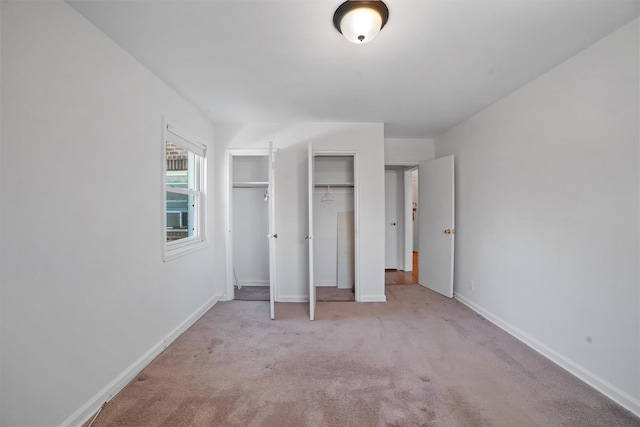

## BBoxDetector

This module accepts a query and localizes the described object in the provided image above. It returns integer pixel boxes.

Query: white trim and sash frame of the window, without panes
[161,117,207,262]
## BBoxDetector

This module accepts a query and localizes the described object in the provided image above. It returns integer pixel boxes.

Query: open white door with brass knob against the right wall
[418,156,455,298]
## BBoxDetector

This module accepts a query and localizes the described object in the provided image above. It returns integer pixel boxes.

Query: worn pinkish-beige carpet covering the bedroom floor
[86,285,640,426]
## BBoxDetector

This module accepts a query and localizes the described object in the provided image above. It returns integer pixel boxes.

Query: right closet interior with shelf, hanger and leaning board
[313,155,355,301]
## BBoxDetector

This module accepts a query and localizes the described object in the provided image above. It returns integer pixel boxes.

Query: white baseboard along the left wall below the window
[60,295,220,426]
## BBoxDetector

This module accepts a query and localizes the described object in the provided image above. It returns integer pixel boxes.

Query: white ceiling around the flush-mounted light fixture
[68,0,640,138]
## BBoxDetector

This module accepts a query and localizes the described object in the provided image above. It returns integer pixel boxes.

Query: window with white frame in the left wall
[163,122,206,261]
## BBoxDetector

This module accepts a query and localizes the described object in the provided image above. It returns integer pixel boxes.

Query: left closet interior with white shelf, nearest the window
[230,155,269,301]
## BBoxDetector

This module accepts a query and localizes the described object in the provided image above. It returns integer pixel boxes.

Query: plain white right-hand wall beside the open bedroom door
[436,19,640,414]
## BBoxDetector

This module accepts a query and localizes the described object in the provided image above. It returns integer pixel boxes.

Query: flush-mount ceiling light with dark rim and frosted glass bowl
[333,0,389,44]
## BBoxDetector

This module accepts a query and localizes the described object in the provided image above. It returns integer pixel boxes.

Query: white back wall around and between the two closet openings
[215,123,385,304]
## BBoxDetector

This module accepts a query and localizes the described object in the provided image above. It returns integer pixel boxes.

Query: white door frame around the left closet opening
[224,148,277,301]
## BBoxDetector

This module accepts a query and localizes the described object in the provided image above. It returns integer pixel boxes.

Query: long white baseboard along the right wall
[453,294,640,417]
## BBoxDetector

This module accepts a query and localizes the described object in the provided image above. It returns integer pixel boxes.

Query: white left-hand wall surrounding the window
[0,1,223,426]
